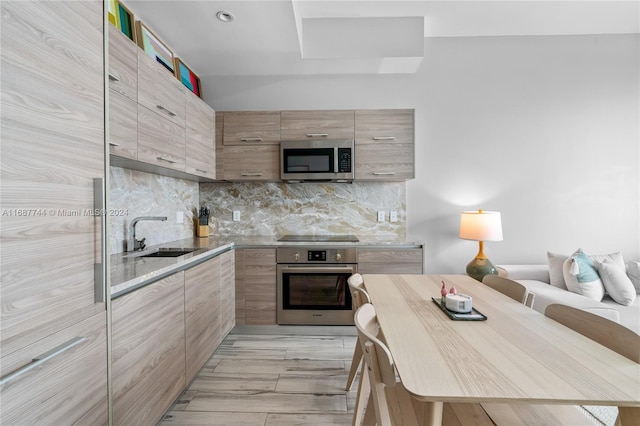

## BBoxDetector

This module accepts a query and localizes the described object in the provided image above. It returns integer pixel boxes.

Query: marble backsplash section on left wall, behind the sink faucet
[109,167,199,253]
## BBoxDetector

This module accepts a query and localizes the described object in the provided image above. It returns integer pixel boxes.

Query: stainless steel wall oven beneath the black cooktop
[276,247,357,325]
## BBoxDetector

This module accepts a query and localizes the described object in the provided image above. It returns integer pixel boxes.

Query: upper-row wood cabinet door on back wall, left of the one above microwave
[223,111,280,145]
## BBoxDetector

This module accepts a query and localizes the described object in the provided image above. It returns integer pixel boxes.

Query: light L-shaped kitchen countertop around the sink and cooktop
[111,235,423,298]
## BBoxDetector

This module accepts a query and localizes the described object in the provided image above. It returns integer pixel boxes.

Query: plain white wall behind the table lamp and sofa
[203,35,640,273]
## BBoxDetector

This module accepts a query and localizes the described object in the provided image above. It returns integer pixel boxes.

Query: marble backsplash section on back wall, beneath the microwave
[200,182,406,239]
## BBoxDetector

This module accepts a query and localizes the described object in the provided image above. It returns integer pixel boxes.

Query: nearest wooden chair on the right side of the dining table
[482,304,640,426]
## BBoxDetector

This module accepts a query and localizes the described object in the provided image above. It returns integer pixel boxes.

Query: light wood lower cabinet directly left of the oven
[235,248,276,325]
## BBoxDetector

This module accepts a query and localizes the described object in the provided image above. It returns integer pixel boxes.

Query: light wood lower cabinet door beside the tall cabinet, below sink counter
[111,272,186,425]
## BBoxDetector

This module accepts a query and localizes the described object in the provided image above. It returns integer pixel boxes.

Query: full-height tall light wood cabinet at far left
[0,0,108,425]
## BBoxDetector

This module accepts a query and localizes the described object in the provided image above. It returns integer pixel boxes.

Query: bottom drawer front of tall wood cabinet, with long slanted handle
[0,311,107,425]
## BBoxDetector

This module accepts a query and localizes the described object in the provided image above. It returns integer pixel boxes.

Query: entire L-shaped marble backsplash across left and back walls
[109,167,406,254]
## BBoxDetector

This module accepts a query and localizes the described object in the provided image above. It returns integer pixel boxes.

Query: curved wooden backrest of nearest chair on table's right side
[544,304,640,364]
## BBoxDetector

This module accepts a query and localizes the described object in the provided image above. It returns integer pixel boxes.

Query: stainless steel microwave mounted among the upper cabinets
[280,139,355,182]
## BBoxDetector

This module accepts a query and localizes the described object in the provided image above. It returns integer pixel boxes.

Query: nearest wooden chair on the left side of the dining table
[354,303,494,426]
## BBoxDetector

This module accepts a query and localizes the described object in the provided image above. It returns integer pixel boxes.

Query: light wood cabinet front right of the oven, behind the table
[358,247,424,274]
